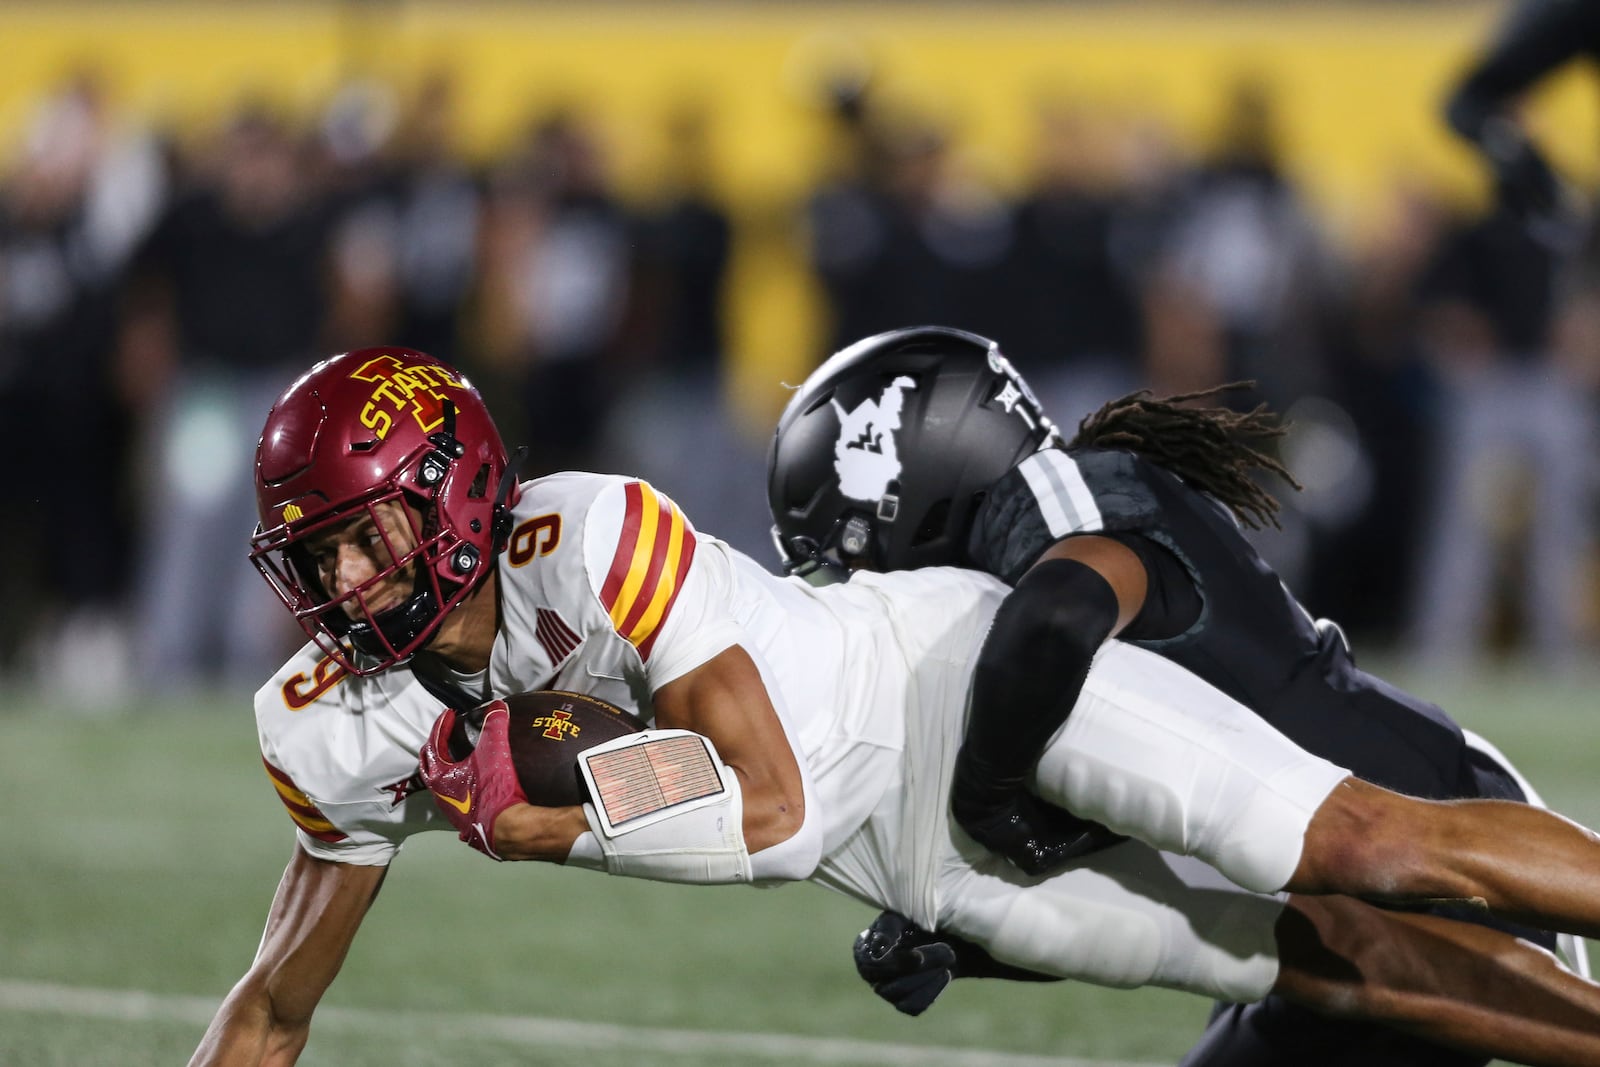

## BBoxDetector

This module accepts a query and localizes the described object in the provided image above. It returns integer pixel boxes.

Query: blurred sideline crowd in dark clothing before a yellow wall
[0,0,1600,701]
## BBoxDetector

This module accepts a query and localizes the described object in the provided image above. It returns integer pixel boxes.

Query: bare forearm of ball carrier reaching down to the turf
[190,848,387,1067]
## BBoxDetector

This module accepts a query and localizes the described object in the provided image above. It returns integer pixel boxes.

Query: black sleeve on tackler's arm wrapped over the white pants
[957,560,1117,801]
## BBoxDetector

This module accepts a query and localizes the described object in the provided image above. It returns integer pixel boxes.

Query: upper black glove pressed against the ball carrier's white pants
[950,750,1128,875]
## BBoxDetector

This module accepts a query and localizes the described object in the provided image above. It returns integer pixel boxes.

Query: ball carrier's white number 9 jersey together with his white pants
[256,474,1344,1000]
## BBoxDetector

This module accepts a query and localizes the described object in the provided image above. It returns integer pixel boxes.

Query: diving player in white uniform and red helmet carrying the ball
[195,349,1600,1064]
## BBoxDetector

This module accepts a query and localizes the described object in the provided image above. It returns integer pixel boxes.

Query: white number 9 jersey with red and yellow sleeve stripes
[256,474,1005,899]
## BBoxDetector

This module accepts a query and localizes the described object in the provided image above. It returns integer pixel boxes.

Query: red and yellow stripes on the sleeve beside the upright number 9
[600,482,694,659]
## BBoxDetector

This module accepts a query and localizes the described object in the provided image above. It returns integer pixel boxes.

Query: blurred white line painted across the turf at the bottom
[0,979,1155,1067]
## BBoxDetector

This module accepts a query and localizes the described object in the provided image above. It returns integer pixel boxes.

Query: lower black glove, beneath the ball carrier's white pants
[854,912,1058,1016]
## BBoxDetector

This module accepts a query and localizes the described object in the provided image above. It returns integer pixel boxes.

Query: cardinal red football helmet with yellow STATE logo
[250,347,515,675]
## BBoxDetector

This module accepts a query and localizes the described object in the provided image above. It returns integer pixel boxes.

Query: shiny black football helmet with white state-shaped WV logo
[766,326,1061,581]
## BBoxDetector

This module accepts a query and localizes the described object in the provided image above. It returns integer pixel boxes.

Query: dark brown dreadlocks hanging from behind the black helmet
[1067,381,1301,530]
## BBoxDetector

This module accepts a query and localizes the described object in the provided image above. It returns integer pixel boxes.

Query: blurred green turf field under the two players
[0,662,1600,1067]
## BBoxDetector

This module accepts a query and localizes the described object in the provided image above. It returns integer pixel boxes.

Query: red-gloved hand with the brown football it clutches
[419,689,645,859]
